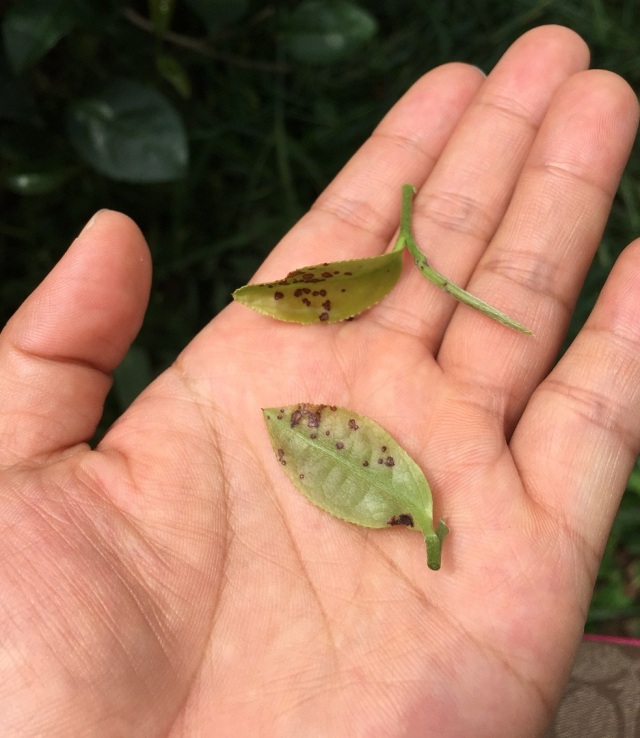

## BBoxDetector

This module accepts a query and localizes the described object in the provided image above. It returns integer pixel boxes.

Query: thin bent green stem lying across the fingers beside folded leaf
[400,185,532,336]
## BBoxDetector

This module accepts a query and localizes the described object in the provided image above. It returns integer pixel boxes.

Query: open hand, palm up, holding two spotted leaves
[0,27,640,738]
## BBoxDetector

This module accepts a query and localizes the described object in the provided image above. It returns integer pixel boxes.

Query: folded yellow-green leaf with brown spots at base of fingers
[233,251,402,325]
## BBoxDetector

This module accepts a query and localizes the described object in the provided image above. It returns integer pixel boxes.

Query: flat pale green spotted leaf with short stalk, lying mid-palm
[262,403,448,569]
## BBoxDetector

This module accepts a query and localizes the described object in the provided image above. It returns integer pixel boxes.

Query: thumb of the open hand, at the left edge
[0,210,151,463]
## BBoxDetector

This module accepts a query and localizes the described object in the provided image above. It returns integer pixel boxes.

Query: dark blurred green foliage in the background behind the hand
[0,0,640,636]
